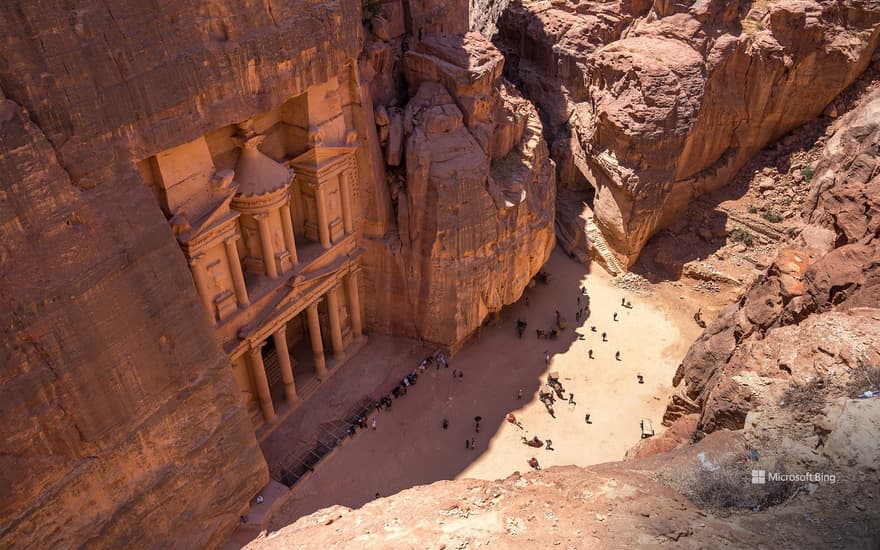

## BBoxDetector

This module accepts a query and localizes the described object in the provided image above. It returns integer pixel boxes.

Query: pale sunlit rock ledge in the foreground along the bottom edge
[247,432,880,549]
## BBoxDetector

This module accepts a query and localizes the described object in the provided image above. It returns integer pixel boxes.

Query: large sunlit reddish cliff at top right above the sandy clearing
[498,0,880,265]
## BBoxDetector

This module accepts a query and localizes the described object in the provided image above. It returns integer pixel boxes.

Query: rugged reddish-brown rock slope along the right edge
[666,88,880,431]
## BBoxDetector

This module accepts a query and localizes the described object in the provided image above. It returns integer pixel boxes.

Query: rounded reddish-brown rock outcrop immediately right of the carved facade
[366,34,555,347]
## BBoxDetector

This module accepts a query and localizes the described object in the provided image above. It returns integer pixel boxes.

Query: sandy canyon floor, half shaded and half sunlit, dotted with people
[262,249,699,530]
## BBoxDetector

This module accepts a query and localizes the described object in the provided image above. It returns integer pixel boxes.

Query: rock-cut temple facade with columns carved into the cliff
[139,78,365,434]
